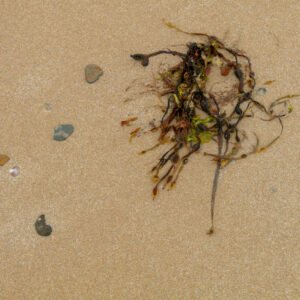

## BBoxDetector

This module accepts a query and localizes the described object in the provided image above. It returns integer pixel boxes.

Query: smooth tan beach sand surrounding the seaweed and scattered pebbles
[0,0,300,300]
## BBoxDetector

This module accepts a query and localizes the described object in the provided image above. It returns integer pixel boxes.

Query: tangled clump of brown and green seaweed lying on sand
[123,23,298,234]
